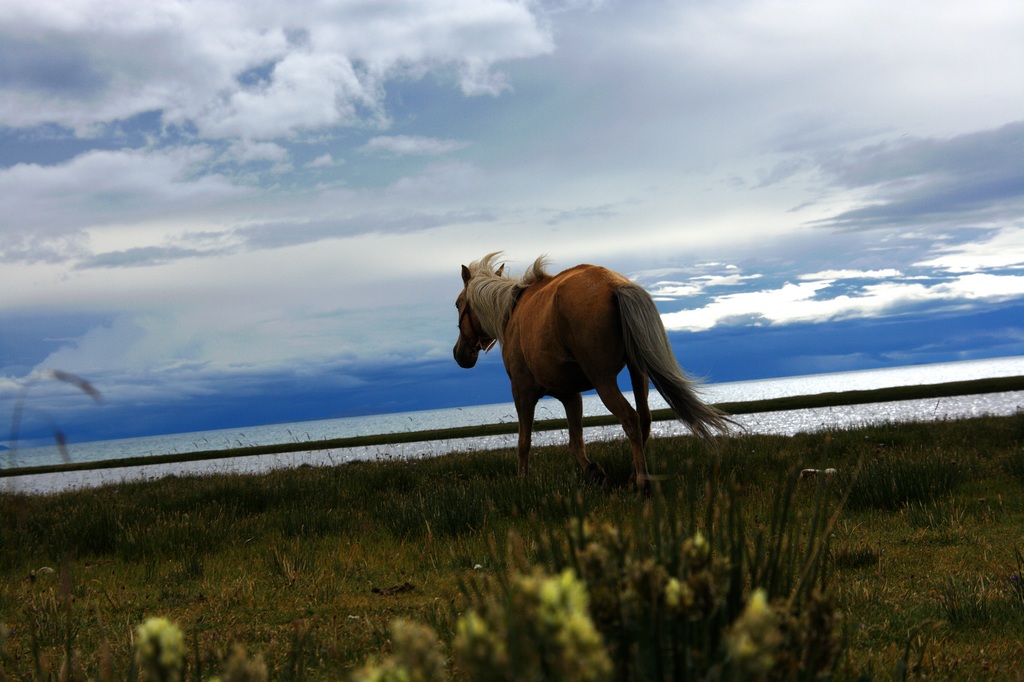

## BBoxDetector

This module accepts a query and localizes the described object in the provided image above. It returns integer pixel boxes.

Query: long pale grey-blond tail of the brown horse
[615,283,735,440]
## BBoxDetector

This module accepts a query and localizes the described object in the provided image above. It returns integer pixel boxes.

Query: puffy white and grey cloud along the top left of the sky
[0,0,553,139]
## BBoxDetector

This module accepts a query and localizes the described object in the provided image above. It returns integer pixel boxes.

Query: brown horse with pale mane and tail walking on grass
[454,253,732,492]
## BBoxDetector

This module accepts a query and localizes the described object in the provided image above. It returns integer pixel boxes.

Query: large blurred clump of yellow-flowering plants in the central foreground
[356,458,843,680]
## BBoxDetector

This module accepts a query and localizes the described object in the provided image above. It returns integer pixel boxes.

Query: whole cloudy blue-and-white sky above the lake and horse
[0,0,1024,442]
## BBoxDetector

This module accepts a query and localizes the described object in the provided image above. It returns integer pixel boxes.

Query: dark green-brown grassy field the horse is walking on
[0,405,1024,680]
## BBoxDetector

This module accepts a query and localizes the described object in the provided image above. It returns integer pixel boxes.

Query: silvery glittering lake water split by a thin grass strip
[0,356,1024,493]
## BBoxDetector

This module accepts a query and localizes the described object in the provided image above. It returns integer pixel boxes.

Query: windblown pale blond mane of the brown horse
[466,251,550,343]
